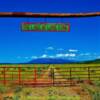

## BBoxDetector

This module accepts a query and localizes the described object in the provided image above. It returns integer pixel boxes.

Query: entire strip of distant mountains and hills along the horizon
[0,58,100,65]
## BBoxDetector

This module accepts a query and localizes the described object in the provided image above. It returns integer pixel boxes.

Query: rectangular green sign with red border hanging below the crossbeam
[21,23,70,32]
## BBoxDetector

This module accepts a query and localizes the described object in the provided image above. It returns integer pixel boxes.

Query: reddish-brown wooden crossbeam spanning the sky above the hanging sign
[0,12,100,18]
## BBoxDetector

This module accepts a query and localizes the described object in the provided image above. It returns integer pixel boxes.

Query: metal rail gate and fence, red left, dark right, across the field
[0,65,100,87]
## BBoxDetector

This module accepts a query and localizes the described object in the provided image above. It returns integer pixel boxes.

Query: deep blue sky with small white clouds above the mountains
[0,0,100,62]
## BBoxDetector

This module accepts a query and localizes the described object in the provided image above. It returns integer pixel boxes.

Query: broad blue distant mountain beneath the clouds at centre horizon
[28,58,74,64]
